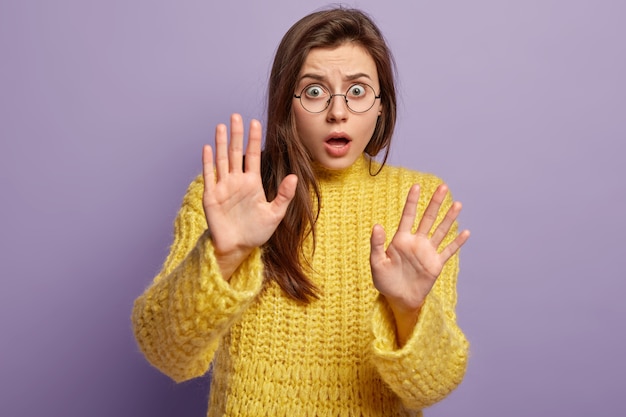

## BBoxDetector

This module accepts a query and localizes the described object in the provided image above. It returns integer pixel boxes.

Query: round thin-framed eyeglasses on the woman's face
[293,84,380,113]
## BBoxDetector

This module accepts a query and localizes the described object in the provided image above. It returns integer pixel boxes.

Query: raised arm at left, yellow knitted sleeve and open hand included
[132,115,297,381]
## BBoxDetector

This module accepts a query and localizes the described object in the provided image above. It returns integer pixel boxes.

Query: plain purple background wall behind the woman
[0,0,626,417]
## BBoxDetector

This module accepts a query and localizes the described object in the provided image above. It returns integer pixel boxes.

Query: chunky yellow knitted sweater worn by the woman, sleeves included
[132,154,468,416]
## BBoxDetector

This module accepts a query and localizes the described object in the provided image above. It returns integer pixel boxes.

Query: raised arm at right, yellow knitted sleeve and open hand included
[371,177,469,410]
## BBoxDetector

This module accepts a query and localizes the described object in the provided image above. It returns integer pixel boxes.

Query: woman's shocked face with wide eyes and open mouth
[293,42,382,169]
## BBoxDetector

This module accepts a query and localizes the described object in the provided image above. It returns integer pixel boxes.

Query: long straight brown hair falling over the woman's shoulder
[261,8,396,302]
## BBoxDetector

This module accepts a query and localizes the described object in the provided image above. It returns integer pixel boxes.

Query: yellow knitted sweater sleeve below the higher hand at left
[131,177,263,382]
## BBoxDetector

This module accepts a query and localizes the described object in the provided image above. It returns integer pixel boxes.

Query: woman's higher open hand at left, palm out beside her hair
[202,114,298,280]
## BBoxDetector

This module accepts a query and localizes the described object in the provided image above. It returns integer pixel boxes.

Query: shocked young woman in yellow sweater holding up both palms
[132,8,469,416]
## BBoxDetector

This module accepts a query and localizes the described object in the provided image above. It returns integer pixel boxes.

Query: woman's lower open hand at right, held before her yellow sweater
[370,184,470,345]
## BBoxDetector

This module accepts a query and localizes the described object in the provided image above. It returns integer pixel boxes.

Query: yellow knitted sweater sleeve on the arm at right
[372,177,469,410]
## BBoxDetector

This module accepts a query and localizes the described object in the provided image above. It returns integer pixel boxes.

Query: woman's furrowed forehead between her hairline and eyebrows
[300,42,378,80]
